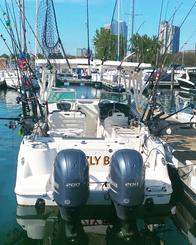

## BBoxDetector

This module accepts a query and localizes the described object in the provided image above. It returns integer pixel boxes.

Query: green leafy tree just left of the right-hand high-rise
[130,33,161,64]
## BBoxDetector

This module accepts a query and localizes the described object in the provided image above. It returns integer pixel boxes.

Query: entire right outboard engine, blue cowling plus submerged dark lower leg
[106,149,145,243]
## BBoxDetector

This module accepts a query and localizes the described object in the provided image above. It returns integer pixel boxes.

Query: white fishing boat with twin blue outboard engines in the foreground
[15,66,177,242]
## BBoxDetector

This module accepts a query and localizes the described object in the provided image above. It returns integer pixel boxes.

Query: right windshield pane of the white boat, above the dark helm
[100,92,130,104]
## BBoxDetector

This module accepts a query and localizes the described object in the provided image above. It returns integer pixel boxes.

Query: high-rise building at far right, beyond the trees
[159,21,180,54]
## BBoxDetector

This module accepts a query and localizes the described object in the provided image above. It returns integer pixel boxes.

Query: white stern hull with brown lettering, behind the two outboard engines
[15,137,172,206]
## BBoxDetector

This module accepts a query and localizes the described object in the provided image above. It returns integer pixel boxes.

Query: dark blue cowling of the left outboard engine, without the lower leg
[53,149,89,207]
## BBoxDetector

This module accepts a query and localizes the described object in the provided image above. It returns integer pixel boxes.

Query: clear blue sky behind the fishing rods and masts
[0,0,196,55]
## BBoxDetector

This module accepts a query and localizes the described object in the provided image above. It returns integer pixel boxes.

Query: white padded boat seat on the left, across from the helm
[48,111,86,136]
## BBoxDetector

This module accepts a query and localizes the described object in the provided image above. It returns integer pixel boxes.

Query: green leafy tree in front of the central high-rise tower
[93,28,127,60]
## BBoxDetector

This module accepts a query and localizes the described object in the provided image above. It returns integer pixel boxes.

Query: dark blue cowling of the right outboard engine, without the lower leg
[109,149,145,207]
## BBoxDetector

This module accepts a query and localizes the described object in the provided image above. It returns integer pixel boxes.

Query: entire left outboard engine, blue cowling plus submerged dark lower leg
[53,149,89,242]
